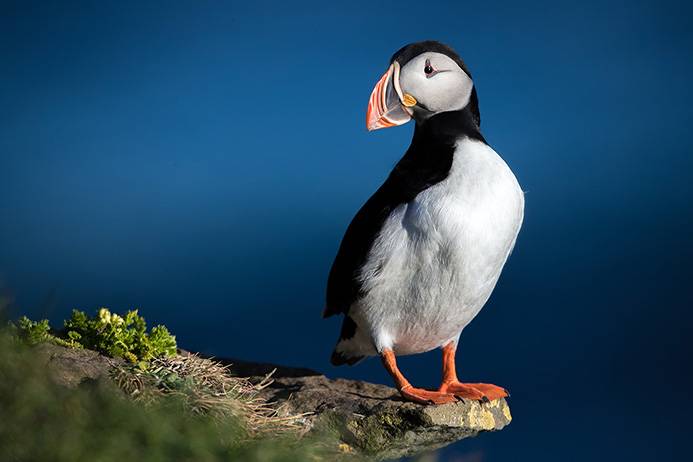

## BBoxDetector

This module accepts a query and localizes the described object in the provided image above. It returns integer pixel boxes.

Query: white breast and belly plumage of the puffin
[350,138,524,354]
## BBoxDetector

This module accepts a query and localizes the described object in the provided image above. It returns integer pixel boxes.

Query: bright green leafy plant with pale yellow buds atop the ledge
[13,308,177,366]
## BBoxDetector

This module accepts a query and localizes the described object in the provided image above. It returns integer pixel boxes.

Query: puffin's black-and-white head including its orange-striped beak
[366,41,479,130]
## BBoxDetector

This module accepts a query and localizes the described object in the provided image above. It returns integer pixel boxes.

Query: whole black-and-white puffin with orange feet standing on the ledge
[323,41,524,404]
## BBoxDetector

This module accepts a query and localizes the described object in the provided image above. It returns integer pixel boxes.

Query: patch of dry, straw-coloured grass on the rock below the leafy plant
[113,354,305,437]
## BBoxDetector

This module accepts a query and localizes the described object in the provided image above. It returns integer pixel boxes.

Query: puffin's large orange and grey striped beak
[366,61,411,131]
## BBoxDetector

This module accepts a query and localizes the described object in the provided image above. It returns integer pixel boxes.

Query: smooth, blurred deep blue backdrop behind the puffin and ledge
[0,0,693,461]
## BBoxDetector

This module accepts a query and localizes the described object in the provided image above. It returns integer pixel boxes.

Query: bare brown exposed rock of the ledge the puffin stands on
[40,345,511,459]
